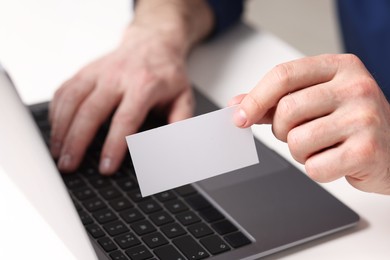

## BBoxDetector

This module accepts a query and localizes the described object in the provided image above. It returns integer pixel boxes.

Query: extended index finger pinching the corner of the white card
[235,55,338,127]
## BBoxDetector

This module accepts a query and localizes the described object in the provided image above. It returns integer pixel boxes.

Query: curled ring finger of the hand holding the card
[287,110,350,164]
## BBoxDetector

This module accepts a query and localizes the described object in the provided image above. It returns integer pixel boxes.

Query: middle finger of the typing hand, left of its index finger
[58,87,120,172]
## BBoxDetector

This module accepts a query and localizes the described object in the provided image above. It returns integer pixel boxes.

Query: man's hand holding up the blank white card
[230,54,390,194]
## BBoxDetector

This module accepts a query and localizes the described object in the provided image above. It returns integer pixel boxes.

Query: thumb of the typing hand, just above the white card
[168,90,195,123]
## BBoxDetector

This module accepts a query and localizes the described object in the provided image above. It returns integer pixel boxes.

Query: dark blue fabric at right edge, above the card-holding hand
[338,0,390,100]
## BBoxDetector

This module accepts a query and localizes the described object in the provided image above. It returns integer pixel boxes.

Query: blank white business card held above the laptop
[126,106,259,197]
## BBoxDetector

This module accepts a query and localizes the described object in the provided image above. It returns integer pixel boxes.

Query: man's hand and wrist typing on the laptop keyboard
[49,0,212,174]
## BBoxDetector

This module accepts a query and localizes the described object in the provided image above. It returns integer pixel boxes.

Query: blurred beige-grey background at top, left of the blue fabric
[244,0,342,55]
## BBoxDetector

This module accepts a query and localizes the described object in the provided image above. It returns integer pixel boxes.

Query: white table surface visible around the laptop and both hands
[0,0,390,259]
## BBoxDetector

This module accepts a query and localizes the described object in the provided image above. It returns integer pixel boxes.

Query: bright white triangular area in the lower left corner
[0,165,77,260]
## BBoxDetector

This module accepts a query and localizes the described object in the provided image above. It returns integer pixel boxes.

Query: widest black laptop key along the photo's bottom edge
[173,236,210,260]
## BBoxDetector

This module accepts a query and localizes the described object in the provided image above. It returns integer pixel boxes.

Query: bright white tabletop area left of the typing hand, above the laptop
[0,0,132,103]
